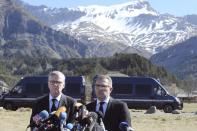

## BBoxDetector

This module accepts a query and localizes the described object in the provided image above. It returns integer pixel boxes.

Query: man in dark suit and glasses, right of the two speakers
[86,75,131,131]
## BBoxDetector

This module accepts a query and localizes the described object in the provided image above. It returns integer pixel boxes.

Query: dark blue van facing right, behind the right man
[92,76,183,113]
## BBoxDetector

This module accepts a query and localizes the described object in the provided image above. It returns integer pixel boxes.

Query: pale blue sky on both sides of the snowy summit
[23,0,197,16]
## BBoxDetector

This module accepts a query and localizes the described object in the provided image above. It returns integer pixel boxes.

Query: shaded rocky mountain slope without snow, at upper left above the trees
[0,0,91,59]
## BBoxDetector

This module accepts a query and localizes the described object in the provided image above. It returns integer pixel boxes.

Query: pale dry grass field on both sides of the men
[0,103,197,131]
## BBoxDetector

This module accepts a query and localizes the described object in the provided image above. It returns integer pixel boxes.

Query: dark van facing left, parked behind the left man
[0,76,85,110]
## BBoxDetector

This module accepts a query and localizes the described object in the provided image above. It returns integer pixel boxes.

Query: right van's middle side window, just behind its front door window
[135,84,151,96]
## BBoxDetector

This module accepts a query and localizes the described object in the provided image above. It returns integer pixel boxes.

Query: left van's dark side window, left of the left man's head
[26,83,41,94]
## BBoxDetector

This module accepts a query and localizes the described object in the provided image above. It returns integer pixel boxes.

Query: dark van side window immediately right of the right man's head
[112,84,133,94]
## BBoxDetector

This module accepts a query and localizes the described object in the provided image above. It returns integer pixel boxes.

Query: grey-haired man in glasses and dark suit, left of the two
[30,71,75,130]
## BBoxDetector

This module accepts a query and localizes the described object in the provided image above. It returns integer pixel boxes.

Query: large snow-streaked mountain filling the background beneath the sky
[16,0,197,56]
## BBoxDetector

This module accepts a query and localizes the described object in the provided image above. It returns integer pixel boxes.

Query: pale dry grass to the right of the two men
[131,104,197,131]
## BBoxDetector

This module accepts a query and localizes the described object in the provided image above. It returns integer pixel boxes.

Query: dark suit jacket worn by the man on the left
[30,94,75,128]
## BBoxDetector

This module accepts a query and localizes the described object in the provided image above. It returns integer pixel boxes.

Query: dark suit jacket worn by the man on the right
[86,98,131,131]
